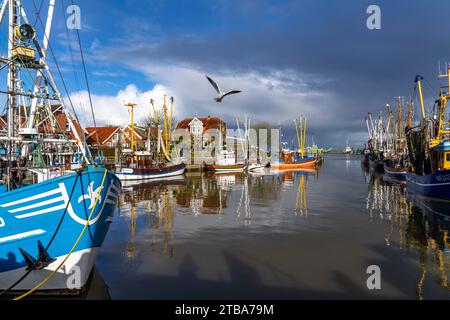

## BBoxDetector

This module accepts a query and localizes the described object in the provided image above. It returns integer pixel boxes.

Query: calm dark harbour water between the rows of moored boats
[90,155,450,299]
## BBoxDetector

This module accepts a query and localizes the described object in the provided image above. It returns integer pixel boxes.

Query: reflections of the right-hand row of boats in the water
[366,172,450,299]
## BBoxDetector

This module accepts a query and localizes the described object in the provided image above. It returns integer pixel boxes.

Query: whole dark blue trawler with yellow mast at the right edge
[406,71,450,199]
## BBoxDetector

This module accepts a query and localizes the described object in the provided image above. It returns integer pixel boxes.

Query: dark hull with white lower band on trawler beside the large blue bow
[116,163,186,181]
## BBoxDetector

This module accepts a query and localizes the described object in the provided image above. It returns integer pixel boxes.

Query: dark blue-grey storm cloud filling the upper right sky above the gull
[100,0,450,145]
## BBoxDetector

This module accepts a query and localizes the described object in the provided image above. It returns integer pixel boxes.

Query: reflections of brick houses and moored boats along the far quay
[120,170,318,258]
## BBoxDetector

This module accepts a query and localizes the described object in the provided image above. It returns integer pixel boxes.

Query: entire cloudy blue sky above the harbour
[2,0,450,148]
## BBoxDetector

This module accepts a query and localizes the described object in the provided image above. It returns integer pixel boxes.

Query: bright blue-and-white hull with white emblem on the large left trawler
[0,166,121,290]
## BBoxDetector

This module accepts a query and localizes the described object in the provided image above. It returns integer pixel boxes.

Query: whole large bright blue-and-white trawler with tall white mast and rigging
[0,0,121,299]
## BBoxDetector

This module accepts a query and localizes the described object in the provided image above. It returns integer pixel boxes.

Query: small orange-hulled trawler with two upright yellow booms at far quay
[270,117,317,170]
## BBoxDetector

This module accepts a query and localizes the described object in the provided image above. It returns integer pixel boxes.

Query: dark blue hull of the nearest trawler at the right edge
[406,170,450,199]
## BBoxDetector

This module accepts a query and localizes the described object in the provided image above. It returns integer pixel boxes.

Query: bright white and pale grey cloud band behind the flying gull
[72,64,352,147]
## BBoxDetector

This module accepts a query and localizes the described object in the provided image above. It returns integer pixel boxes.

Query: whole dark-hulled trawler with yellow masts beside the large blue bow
[116,96,186,182]
